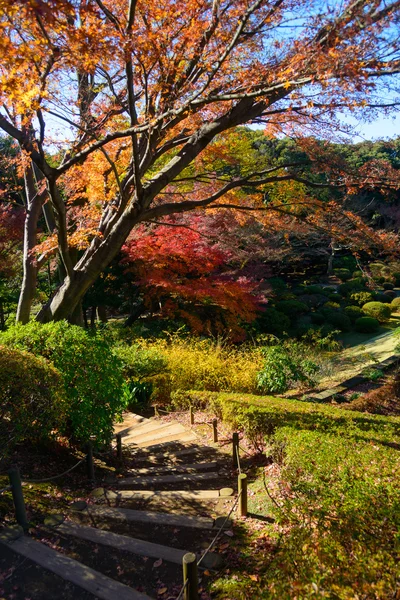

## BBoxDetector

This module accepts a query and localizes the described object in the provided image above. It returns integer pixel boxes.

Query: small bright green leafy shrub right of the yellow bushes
[257,343,319,393]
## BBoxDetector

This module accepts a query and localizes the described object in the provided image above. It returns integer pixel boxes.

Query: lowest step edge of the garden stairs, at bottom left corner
[0,536,151,600]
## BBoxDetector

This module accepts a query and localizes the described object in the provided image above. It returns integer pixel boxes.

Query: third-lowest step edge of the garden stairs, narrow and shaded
[81,505,214,529]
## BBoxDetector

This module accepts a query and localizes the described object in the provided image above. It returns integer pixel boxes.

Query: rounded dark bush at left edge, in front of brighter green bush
[0,346,67,459]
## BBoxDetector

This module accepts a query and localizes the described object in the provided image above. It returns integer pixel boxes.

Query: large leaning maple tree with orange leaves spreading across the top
[0,0,400,321]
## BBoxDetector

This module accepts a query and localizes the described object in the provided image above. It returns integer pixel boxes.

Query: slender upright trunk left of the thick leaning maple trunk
[16,166,46,323]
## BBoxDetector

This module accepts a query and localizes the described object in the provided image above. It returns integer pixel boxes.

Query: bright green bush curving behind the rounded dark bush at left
[0,321,124,444]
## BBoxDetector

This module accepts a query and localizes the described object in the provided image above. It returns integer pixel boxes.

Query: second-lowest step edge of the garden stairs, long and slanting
[56,522,187,565]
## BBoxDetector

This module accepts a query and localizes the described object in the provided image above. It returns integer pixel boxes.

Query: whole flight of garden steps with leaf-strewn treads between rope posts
[0,414,235,600]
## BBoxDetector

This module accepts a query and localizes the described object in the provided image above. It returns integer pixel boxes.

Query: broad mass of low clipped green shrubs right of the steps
[186,392,400,600]
